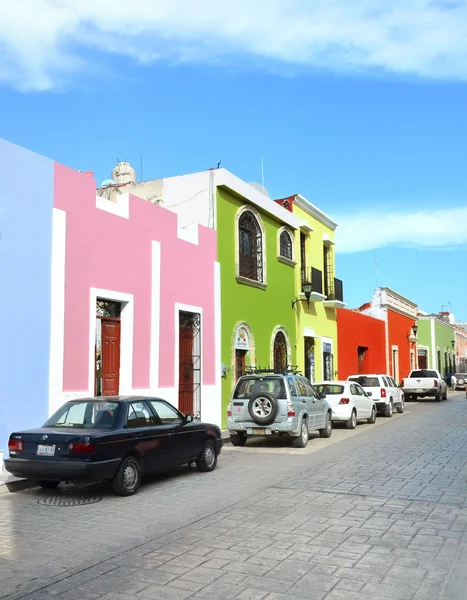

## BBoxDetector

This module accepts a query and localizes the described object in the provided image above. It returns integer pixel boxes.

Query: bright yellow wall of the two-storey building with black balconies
[293,203,338,381]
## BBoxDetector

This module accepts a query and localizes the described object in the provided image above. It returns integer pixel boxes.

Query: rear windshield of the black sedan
[43,400,118,429]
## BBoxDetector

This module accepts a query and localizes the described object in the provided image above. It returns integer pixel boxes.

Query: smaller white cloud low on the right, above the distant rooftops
[336,207,467,254]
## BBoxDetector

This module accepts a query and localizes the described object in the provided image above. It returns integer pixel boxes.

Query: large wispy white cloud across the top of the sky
[0,0,467,90]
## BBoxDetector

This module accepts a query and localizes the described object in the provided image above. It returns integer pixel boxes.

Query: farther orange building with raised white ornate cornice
[358,287,417,383]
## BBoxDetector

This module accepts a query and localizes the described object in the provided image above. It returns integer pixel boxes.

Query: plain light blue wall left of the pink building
[0,139,54,460]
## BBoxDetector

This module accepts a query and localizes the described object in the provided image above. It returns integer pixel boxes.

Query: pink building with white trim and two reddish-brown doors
[49,163,221,424]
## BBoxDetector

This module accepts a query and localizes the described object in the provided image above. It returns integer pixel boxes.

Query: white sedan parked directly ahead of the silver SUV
[313,381,376,429]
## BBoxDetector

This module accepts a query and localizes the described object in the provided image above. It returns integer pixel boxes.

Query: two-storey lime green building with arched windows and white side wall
[116,167,298,424]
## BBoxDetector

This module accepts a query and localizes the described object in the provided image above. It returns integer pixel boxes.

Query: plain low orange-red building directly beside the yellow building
[337,308,386,379]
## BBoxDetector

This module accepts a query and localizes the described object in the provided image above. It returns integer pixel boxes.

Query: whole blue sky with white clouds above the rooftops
[0,0,467,320]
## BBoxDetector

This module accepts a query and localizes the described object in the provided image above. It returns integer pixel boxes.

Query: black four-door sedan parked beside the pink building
[5,396,222,496]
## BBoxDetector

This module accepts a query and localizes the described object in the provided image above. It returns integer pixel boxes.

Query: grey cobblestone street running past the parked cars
[0,392,467,600]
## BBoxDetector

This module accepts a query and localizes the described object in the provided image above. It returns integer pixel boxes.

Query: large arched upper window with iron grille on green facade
[238,210,263,282]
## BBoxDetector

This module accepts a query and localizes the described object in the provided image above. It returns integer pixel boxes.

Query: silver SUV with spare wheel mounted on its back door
[227,369,332,448]
